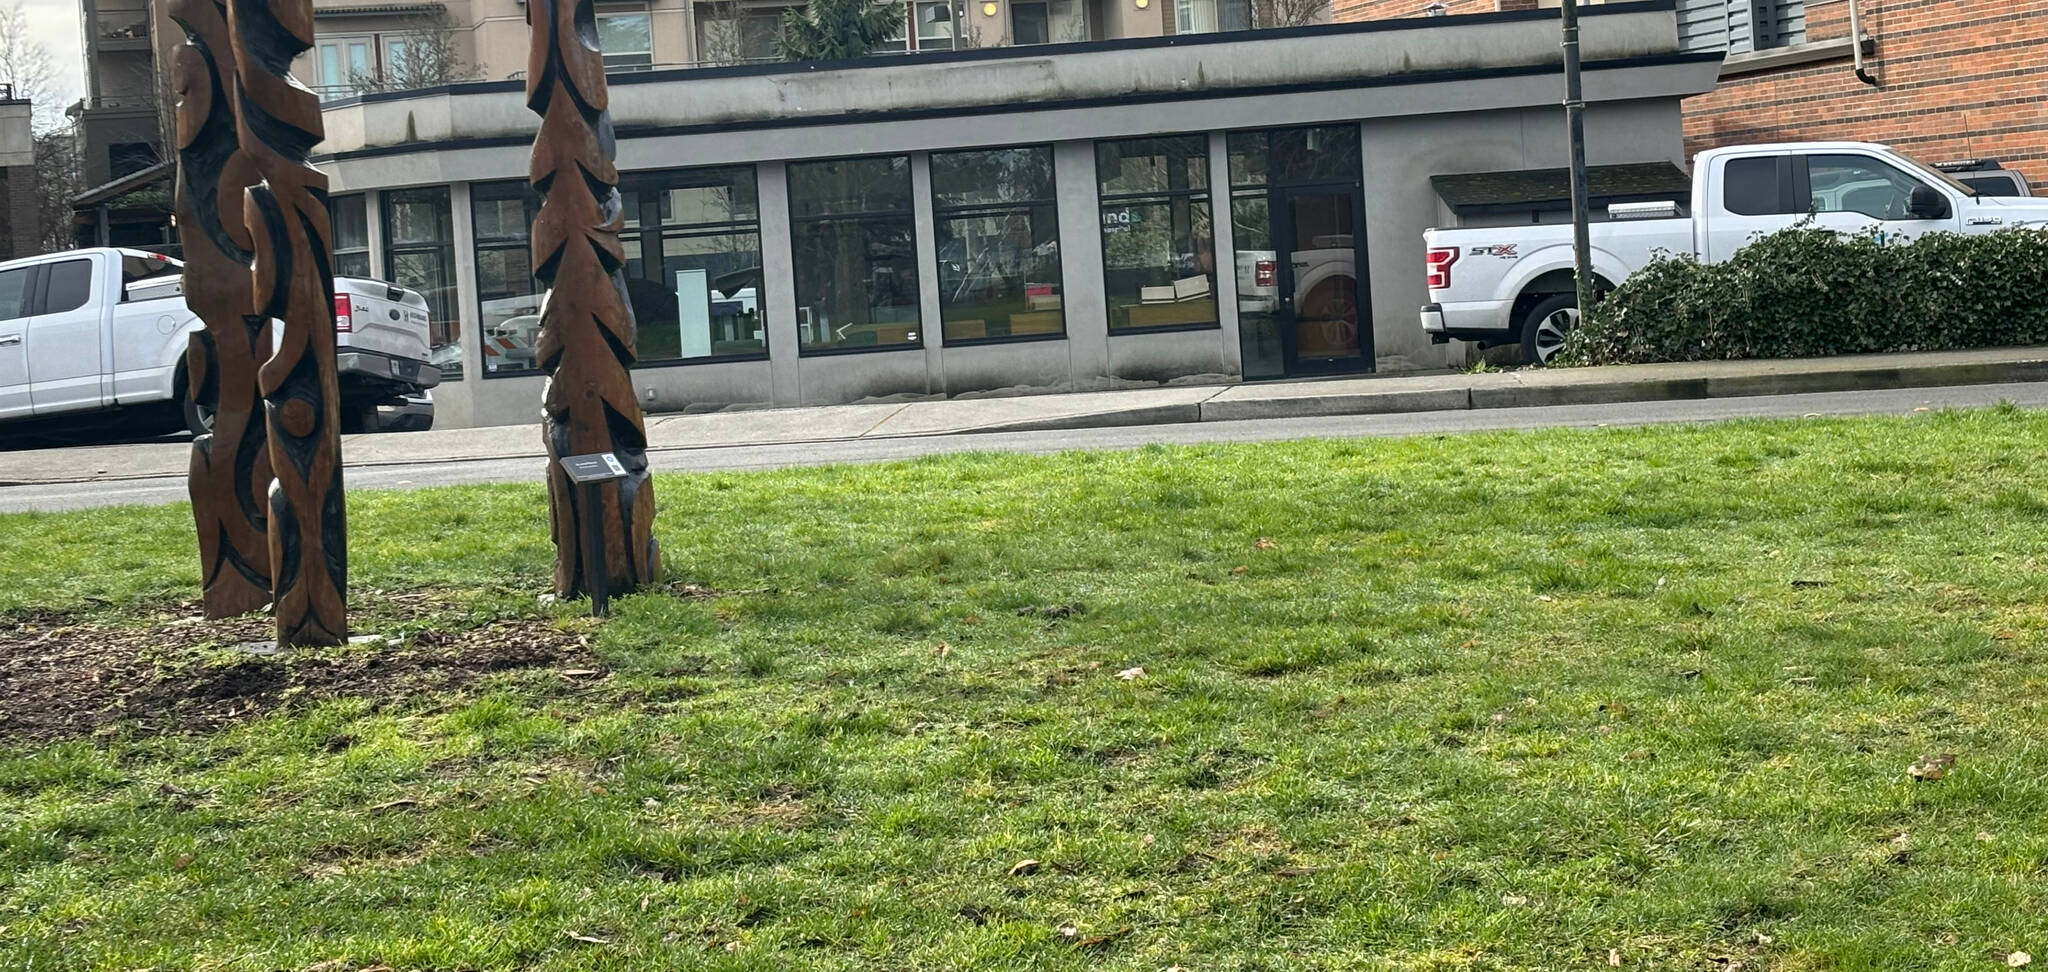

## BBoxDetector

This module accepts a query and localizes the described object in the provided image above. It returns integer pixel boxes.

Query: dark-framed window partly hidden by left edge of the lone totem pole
[469,180,541,377]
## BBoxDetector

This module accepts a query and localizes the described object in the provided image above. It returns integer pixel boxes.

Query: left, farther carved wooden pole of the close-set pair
[168,0,270,618]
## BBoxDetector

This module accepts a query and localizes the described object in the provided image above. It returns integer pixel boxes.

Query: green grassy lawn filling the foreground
[0,409,2048,972]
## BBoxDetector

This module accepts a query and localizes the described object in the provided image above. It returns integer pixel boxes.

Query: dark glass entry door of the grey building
[1274,186,1372,374]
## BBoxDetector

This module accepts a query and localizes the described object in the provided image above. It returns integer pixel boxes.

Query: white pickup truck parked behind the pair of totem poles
[0,248,440,432]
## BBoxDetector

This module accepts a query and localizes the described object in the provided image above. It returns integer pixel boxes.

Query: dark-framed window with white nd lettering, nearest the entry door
[1096,135,1217,332]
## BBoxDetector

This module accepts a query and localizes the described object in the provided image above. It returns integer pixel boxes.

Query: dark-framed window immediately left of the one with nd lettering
[932,145,1067,342]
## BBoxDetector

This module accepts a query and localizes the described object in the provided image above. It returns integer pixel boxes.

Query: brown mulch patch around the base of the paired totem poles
[0,595,602,745]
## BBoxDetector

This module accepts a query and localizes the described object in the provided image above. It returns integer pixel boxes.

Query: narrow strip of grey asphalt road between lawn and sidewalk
[0,383,2048,514]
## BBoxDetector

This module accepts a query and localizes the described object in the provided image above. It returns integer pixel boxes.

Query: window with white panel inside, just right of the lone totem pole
[618,166,768,364]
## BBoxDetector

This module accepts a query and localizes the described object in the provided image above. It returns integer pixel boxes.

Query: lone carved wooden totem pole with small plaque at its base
[526,0,662,598]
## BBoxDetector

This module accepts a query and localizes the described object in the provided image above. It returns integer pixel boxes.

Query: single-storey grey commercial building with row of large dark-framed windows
[315,0,1720,426]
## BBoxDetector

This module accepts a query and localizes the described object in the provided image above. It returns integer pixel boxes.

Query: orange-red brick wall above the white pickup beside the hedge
[1686,0,2048,186]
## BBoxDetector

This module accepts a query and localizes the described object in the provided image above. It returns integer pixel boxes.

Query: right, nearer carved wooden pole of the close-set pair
[227,0,348,645]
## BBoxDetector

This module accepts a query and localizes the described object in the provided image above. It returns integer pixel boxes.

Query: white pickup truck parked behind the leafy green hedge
[1421,141,2048,362]
